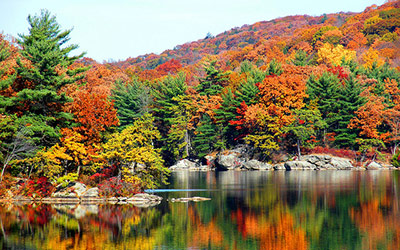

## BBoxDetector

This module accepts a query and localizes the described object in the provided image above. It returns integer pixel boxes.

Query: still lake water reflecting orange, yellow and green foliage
[0,171,400,250]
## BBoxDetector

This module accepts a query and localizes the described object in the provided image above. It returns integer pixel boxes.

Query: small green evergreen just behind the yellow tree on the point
[111,78,151,130]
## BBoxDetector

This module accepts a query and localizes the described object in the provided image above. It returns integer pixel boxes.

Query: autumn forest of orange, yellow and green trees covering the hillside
[0,1,400,197]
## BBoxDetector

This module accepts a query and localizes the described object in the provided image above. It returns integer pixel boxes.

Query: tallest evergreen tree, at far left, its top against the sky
[0,10,86,146]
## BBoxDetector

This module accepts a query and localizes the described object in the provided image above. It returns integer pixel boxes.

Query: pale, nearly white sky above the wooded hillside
[0,0,385,62]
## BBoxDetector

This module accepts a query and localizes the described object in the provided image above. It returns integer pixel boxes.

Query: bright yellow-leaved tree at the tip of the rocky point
[100,113,169,188]
